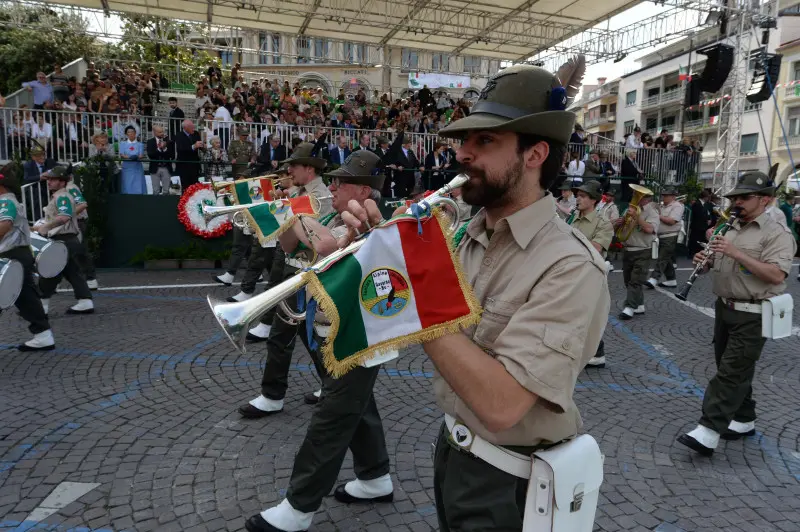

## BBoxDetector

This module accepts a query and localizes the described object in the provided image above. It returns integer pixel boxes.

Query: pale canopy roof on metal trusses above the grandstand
[48,0,640,61]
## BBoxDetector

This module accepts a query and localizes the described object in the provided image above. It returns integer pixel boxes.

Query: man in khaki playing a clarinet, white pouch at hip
[678,172,797,456]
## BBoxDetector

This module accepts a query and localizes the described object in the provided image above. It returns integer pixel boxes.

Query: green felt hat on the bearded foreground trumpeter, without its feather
[439,65,575,144]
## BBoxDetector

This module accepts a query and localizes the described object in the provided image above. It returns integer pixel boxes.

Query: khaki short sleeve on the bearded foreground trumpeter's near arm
[490,258,610,412]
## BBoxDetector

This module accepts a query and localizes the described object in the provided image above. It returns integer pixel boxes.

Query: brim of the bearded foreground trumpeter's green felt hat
[439,111,575,144]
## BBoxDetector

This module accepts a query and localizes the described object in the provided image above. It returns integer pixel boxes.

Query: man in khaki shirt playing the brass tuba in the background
[611,187,659,320]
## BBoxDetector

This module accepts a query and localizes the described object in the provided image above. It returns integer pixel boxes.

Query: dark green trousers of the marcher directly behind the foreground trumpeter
[286,331,389,512]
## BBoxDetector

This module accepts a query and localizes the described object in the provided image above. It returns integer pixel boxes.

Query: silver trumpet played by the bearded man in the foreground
[207,174,469,353]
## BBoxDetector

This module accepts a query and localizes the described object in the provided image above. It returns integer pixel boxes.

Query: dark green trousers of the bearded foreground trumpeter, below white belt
[433,423,528,532]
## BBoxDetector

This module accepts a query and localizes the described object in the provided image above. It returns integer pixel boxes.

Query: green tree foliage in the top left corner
[0,4,98,94]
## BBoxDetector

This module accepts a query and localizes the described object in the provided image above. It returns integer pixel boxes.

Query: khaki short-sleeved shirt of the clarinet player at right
[713,212,797,301]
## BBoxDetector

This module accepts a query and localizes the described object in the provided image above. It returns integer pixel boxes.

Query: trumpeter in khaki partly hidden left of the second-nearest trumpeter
[239,142,333,418]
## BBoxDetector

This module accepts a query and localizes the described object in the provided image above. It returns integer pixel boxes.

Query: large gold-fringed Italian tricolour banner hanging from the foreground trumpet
[305,213,482,378]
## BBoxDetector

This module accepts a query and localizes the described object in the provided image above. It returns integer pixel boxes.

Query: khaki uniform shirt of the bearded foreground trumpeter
[434,194,610,446]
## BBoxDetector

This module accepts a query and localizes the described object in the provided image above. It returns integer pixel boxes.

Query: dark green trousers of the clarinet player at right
[700,299,767,433]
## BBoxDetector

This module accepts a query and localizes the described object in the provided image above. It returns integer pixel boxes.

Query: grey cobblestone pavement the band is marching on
[0,262,800,532]
